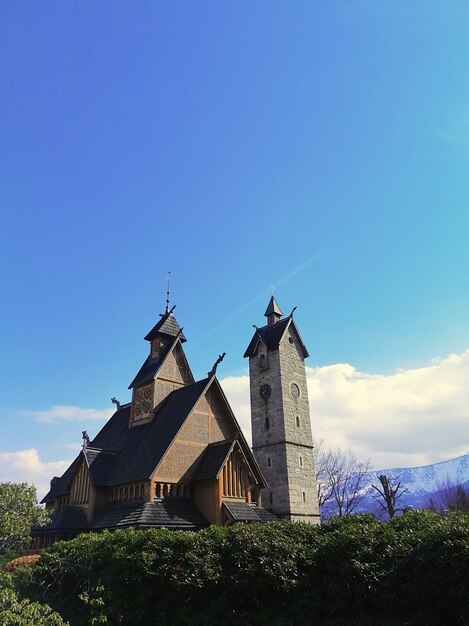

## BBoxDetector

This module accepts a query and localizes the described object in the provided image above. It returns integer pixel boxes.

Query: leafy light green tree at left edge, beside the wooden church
[0,483,48,552]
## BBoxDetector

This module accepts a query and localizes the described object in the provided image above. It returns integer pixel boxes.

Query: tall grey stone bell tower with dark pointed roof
[244,296,319,524]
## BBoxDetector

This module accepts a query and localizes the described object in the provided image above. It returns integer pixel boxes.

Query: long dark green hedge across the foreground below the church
[14,512,469,626]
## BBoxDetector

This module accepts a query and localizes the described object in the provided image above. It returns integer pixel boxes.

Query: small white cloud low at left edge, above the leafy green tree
[0,448,71,500]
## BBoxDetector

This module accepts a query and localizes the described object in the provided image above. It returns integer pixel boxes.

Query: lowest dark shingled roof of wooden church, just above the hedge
[91,498,208,530]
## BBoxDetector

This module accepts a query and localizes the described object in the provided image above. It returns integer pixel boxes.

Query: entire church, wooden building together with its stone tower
[31,296,319,549]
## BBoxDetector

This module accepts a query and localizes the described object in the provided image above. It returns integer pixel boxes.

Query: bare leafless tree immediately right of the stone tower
[315,441,370,518]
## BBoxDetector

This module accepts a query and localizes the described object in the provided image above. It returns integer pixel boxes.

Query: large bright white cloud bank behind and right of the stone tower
[222,350,469,468]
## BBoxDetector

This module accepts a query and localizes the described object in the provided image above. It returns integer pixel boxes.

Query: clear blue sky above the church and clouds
[0,0,469,494]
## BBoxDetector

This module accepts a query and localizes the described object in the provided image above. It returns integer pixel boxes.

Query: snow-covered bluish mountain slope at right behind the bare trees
[357,453,469,513]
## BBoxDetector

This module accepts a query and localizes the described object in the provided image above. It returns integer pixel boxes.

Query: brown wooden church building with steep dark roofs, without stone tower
[31,307,276,548]
